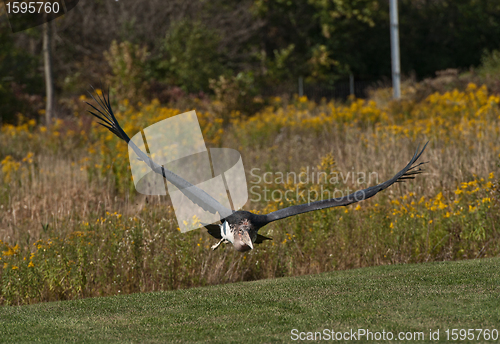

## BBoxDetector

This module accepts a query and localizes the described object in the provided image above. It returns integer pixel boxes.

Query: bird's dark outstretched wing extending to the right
[261,142,429,223]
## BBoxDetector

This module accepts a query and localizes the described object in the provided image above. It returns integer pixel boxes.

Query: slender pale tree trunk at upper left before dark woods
[43,22,54,126]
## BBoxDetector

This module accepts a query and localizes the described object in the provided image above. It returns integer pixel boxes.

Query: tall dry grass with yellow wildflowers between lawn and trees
[0,85,500,304]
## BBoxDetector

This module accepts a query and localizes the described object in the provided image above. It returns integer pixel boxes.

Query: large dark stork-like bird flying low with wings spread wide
[87,91,428,252]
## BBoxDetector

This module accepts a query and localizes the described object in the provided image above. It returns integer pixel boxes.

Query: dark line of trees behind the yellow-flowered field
[0,0,500,121]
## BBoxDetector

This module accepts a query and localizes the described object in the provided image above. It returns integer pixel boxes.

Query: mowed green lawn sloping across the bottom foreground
[0,258,500,343]
